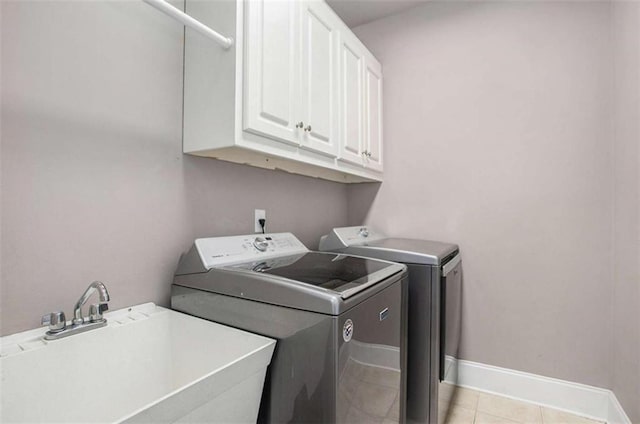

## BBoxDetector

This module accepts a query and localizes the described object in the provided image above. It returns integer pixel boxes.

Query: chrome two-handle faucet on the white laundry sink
[42,281,109,340]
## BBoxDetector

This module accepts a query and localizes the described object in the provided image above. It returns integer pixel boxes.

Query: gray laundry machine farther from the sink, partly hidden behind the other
[320,227,462,424]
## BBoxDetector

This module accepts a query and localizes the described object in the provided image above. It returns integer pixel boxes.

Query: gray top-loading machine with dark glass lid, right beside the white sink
[171,233,407,423]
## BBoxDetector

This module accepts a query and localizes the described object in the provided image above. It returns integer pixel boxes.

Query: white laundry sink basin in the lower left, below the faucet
[0,303,275,423]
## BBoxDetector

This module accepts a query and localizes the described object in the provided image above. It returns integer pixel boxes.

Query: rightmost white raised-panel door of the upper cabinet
[364,58,382,172]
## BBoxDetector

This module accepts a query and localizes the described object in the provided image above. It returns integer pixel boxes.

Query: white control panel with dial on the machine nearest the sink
[195,233,309,269]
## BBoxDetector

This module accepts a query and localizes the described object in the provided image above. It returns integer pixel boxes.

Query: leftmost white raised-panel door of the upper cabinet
[243,0,302,145]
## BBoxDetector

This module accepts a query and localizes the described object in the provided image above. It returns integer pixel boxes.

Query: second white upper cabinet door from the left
[300,0,341,157]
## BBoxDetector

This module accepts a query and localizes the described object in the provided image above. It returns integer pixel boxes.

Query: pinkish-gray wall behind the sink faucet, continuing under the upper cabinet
[0,1,347,334]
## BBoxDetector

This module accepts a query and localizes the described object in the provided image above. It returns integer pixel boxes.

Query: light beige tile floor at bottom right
[445,387,601,424]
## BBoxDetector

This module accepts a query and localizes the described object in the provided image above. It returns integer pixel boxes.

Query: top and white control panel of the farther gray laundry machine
[320,226,458,265]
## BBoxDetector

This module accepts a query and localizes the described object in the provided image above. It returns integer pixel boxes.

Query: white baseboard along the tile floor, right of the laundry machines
[458,360,631,424]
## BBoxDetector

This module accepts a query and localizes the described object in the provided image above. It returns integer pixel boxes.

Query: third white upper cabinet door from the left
[338,32,364,165]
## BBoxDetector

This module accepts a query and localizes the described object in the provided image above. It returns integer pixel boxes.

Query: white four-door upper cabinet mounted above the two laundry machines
[183,0,382,183]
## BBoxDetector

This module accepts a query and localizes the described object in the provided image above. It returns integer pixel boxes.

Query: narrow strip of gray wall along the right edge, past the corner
[612,2,640,422]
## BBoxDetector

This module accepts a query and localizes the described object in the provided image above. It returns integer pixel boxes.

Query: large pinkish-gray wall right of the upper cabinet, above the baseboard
[349,2,613,387]
